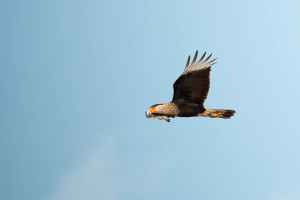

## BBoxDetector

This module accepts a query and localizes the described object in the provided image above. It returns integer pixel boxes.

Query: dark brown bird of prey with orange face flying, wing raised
[145,50,235,122]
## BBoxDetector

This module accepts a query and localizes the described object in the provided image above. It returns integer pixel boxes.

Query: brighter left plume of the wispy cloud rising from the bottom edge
[50,138,122,200]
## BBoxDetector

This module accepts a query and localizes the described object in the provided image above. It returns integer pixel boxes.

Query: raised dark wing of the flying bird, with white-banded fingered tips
[172,51,216,105]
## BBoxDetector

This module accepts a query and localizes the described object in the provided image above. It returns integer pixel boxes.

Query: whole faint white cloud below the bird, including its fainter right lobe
[49,135,174,200]
